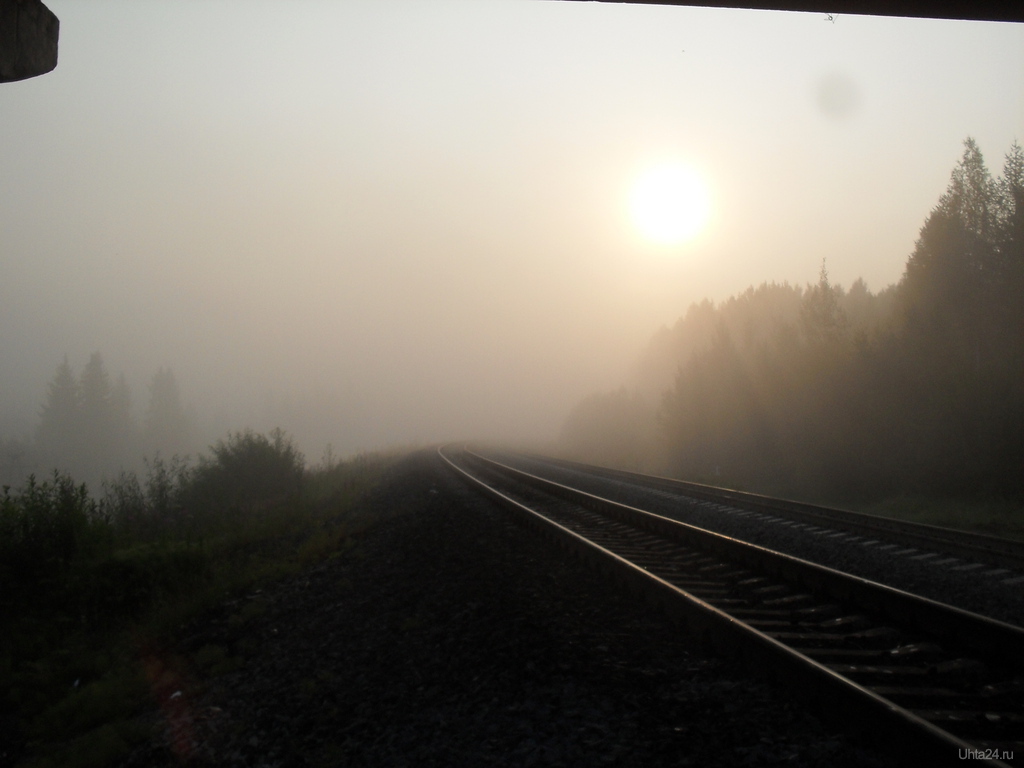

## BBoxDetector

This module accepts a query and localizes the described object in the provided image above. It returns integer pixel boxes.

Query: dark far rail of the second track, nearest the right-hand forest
[501,454,1024,570]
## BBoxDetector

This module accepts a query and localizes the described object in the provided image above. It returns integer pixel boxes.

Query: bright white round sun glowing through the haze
[631,163,711,246]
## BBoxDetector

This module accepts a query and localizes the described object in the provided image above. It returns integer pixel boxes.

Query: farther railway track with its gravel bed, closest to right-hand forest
[488,453,1024,627]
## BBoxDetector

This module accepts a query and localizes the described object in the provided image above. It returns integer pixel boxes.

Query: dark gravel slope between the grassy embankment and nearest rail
[124,451,896,768]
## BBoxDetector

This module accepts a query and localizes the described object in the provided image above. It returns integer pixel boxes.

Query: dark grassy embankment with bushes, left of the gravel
[0,432,396,768]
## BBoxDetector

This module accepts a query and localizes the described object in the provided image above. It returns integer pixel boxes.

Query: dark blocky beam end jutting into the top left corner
[0,0,60,83]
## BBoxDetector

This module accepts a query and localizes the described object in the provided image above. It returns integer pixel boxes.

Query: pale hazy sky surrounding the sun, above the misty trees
[0,0,1024,459]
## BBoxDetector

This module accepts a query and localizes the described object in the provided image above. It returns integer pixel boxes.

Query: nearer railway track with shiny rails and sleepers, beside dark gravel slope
[441,449,1024,766]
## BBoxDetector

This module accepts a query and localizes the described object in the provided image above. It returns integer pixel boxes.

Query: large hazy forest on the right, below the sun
[562,138,1024,502]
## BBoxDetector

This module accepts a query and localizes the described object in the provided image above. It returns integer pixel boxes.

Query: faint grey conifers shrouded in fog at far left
[0,352,193,485]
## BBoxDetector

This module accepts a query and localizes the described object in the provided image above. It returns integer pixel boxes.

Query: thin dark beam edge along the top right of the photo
[565,0,1024,22]
